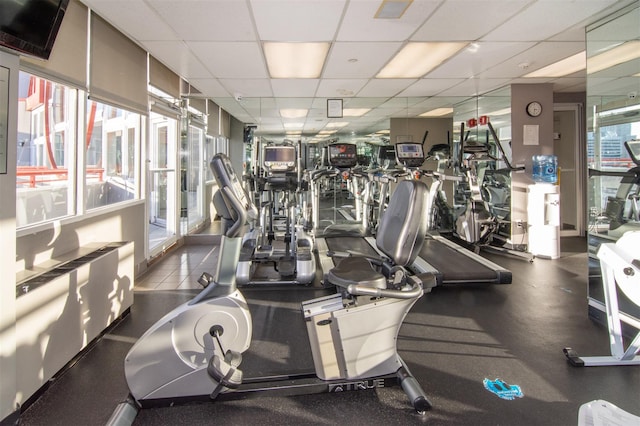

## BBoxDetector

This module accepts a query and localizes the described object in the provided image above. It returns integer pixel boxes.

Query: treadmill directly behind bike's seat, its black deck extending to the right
[396,142,512,285]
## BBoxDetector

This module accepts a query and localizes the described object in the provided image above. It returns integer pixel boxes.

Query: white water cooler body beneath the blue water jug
[527,183,560,259]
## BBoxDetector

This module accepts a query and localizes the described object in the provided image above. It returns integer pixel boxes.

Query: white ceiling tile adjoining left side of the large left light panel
[187,41,268,79]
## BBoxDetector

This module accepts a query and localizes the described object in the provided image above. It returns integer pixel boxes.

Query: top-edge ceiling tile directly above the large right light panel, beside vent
[411,0,532,41]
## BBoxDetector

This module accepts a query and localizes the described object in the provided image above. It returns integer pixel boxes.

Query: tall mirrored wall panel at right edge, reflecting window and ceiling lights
[587,3,640,329]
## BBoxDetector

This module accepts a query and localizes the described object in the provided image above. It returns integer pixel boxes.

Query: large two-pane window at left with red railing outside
[16,72,142,228]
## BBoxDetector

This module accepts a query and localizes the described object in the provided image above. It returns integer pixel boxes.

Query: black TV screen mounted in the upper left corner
[0,0,69,59]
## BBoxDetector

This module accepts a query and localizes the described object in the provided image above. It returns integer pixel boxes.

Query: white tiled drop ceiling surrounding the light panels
[82,0,634,137]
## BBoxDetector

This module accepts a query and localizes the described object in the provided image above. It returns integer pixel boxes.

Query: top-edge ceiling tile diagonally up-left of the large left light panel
[149,0,256,41]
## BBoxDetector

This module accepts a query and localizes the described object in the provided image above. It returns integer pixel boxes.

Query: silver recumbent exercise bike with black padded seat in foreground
[125,154,435,413]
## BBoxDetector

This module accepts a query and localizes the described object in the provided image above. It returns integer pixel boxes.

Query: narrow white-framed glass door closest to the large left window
[147,112,177,254]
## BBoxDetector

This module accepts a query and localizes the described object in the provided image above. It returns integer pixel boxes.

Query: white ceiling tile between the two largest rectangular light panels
[322,42,402,78]
